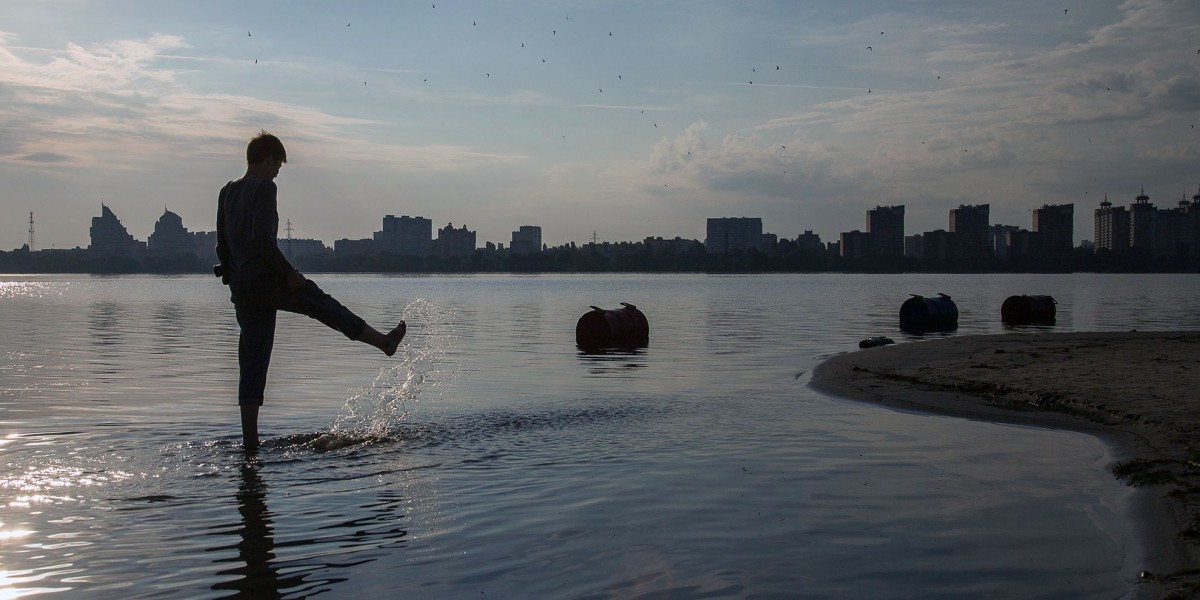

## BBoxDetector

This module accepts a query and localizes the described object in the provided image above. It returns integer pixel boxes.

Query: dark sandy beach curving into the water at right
[812,331,1200,598]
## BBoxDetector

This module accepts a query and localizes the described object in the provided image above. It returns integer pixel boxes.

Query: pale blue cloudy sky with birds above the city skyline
[0,0,1200,250]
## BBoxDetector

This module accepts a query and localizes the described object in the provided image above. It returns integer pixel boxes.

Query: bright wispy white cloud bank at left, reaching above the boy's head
[0,35,525,169]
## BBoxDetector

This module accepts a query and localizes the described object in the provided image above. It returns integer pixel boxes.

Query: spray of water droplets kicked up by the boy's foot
[318,298,457,445]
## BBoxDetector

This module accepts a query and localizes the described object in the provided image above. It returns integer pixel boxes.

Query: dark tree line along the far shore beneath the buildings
[0,240,1200,274]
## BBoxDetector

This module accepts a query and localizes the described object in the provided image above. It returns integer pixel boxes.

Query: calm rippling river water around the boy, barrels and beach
[0,274,1200,599]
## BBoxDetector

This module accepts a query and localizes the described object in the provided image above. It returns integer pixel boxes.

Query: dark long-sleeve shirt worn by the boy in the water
[217,178,295,284]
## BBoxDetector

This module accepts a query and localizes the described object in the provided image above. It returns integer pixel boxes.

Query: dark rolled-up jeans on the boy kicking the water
[229,281,366,406]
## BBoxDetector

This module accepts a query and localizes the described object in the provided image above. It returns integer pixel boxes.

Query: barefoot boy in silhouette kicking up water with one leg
[215,131,407,452]
